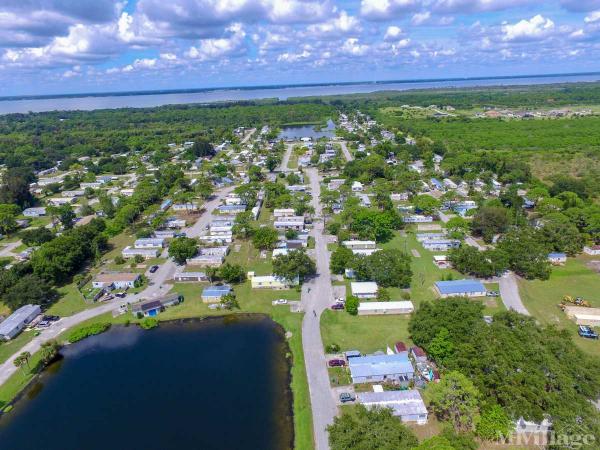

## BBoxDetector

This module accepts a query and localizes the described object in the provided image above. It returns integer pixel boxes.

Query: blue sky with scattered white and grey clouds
[0,0,600,96]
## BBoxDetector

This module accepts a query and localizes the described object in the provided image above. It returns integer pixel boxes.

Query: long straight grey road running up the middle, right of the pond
[302,168,338,450]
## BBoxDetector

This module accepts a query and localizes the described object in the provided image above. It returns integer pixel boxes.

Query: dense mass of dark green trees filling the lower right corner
[409,298,600,442]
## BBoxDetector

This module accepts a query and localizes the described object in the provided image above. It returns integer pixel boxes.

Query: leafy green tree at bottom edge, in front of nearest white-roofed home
[327,405,418,450]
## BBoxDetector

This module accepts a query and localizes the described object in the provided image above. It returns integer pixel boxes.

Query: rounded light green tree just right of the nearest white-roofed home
[425,371,481,431]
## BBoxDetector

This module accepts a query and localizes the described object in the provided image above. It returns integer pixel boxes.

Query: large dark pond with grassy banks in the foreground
[0,317,293,450]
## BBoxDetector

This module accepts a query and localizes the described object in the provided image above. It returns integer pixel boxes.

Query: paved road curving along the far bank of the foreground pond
[0,187,234,385]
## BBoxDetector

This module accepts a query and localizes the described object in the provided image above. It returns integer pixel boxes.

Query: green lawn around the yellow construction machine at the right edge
[519,256,600,355]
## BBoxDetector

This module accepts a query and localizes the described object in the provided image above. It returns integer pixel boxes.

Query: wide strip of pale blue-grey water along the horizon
[0,73,600,114]
